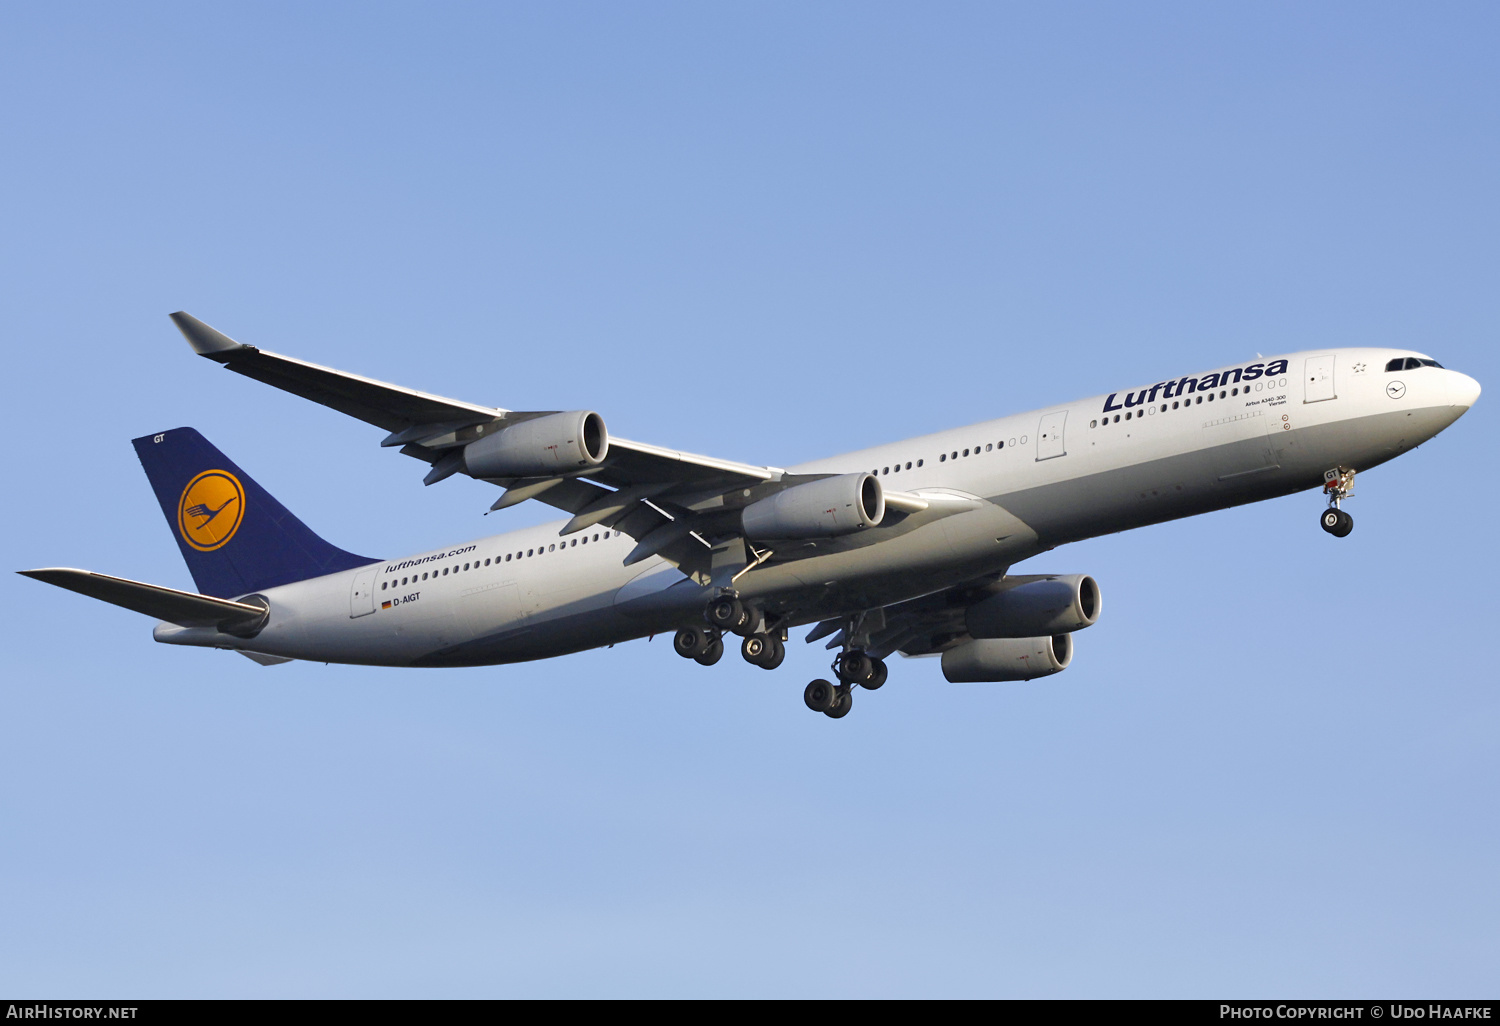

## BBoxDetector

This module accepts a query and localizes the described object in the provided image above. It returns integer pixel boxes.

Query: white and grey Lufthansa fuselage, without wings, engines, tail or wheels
[156,350,1479,666]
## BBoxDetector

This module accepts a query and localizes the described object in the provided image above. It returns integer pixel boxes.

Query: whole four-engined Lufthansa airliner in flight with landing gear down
[24,314,1479,719]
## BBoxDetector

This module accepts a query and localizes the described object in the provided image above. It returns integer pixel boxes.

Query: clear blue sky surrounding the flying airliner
[0,3,1500,998]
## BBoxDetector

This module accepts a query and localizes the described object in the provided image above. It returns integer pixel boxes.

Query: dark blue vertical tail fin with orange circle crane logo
[132,428,378,599]
